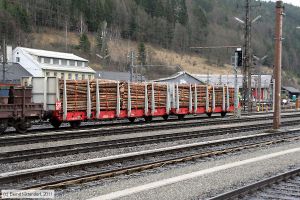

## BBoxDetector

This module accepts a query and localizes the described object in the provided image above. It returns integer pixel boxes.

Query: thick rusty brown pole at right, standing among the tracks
[273,1,284,129]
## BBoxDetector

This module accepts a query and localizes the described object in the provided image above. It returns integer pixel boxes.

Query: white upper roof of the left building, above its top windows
[16,47,88,62]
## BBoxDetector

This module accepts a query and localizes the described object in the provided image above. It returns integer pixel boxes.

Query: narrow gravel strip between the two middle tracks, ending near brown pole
[0,121,288,173]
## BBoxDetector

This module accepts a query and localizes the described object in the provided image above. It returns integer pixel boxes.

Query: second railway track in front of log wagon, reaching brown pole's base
[0,118,300,164]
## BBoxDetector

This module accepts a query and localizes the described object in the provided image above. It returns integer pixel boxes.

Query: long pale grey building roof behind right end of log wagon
[194,74,272,88]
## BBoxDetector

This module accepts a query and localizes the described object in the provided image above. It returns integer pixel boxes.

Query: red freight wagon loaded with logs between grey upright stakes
[27,77,234,128]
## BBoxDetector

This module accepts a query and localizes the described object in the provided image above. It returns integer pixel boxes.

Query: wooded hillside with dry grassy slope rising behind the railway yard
[0,0,300,84]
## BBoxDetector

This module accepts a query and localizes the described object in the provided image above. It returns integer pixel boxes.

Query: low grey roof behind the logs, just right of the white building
[95,71,146,81]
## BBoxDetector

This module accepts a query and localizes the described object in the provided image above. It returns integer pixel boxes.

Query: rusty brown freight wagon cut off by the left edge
[0,84,44,134]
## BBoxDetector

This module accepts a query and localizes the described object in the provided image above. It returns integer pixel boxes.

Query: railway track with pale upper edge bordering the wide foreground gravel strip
[0,129,300,189]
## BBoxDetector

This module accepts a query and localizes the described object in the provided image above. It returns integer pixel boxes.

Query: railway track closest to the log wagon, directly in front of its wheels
[0,113,300,147]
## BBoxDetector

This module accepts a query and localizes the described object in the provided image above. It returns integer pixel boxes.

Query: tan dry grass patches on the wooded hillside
[31,29,278,79]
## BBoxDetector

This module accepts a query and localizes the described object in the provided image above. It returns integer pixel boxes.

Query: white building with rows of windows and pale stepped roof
[13,47,96,80]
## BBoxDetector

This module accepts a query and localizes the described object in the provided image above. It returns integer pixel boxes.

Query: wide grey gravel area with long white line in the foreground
[56,141,300,200]
